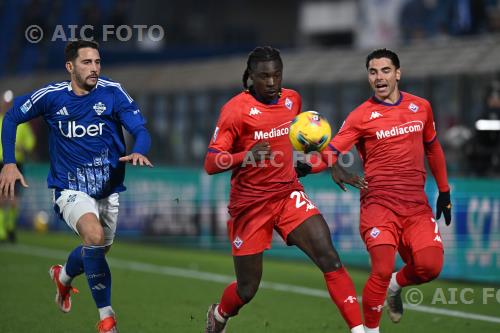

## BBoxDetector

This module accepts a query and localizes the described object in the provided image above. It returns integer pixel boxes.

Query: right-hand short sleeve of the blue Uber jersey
[113,85,146,133]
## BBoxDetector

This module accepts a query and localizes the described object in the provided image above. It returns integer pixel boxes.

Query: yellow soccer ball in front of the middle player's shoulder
[288,111,332,153]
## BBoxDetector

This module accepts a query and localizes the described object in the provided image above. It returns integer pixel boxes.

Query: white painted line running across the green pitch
[0,244,500,323]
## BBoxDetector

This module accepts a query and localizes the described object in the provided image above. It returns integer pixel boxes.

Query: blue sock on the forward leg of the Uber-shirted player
[83,246,111,308]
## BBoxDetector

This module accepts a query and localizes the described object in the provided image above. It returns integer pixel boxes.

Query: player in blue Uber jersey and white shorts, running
[0,40,152,333]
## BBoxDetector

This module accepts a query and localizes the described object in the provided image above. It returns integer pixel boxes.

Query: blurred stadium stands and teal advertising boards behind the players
[0,0,500,330]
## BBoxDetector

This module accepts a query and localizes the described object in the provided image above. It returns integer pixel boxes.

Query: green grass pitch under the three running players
[0,232,500,333]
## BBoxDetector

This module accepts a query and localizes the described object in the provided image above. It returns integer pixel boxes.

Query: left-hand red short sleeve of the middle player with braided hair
[208,105,241,153]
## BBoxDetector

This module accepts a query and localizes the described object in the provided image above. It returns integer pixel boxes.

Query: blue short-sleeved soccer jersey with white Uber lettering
[4,78,145,199]
